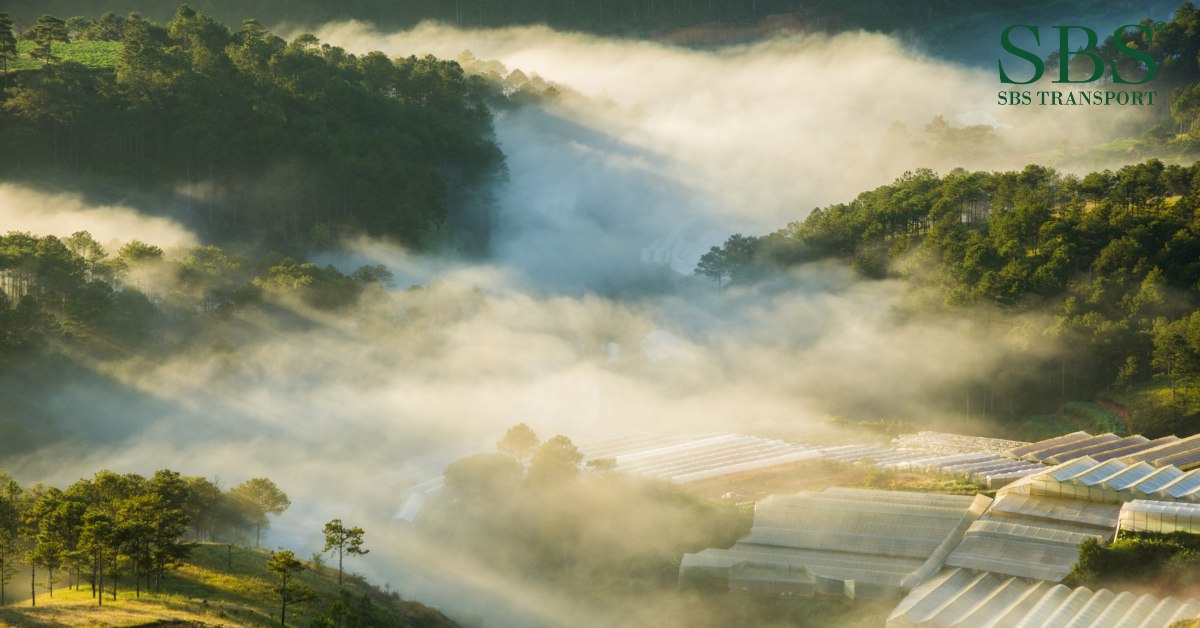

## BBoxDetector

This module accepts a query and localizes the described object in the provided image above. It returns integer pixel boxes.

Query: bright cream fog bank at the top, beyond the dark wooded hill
[316,22,1162,231]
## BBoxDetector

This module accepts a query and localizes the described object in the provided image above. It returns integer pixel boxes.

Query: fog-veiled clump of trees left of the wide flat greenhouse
[416,453,750,597]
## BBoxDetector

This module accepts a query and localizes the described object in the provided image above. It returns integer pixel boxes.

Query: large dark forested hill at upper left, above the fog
[0,5,503,251]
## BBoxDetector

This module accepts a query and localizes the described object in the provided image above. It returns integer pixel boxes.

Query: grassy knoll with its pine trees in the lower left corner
[0,469,454,627]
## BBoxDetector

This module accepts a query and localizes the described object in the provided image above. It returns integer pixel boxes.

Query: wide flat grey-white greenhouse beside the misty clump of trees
[679,489,990,598]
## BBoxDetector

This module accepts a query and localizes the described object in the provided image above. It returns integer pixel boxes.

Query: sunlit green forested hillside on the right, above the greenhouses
[696,160,1200,435]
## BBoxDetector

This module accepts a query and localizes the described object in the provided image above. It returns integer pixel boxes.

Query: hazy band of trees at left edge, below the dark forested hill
[0,232,391,369]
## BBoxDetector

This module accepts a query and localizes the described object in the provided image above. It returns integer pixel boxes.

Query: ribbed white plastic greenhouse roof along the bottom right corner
[887,569,1200,628]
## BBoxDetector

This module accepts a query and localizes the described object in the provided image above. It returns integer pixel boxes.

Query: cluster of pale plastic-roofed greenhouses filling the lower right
[679,432,1200,627]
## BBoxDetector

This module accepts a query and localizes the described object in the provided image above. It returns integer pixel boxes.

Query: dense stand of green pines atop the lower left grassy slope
[0,469,289,605]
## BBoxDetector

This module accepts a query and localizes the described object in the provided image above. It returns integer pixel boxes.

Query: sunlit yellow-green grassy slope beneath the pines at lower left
[0,543,455,627]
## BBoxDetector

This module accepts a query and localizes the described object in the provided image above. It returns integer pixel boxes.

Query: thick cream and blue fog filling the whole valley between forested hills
[0,23,1152,626]
